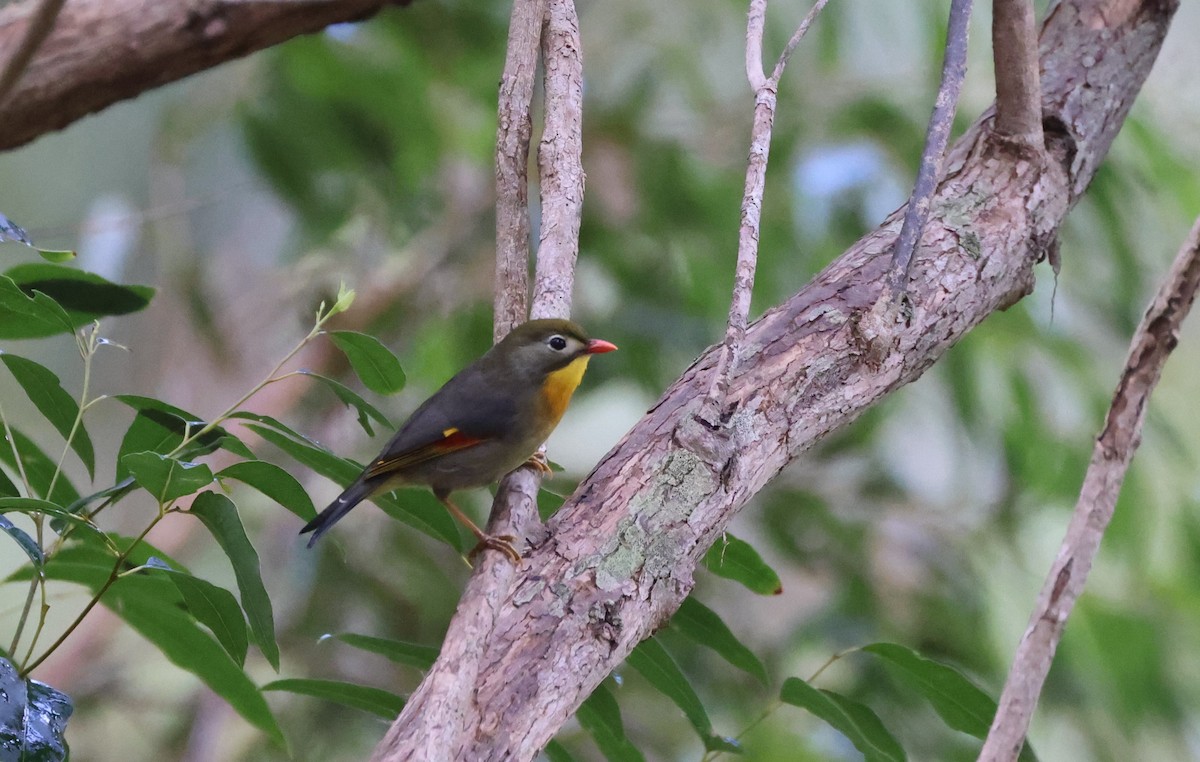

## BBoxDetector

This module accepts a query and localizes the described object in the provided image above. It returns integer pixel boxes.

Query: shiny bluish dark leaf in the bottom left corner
[0,656,74,762]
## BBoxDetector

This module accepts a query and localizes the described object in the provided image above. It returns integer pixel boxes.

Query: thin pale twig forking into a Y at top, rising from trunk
[706,0,829,410]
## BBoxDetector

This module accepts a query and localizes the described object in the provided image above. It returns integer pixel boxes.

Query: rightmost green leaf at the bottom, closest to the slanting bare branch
[862,643,1036,760]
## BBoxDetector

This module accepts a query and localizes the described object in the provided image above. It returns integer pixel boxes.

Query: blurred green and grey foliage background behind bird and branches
[0,0,1200,762]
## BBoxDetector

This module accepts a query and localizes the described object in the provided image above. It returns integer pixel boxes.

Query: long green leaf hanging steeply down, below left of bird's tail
[188,492,280,672]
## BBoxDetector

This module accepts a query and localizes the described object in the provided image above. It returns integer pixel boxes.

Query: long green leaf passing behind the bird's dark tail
[246,424,463,553]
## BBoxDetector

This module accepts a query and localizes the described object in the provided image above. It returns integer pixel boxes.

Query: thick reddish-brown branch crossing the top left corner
[0,0,410,150]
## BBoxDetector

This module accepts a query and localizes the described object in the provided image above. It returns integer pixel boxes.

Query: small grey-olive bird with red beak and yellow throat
[300,319,617,563]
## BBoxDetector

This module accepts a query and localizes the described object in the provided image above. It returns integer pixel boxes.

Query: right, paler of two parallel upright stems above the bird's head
[530,0,584,318]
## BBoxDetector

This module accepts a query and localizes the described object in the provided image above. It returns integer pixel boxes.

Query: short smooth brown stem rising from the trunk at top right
[991,0,1043,150]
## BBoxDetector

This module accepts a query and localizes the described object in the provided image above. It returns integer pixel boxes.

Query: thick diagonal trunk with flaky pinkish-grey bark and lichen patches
[377,0,1177,761]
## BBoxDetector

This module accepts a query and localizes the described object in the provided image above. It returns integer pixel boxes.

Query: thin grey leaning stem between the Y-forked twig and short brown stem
[890,0,971,290]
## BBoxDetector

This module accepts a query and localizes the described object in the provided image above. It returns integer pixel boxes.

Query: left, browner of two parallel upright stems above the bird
[493,0,546,341]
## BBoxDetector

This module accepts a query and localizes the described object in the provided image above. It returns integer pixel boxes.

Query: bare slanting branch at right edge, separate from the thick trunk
[979,220,1200,762]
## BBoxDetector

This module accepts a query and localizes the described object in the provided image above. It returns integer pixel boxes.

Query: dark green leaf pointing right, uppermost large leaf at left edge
[0,263,154,338]
